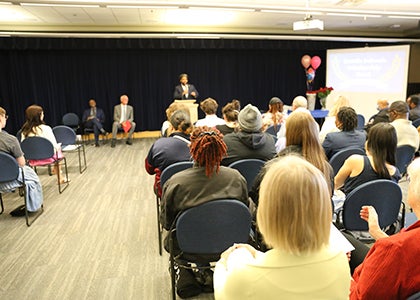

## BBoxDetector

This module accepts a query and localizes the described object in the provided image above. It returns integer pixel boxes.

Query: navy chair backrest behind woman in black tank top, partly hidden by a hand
[343,179,402,231]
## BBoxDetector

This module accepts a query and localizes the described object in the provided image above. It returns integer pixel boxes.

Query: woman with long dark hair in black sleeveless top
[334,123,401,195]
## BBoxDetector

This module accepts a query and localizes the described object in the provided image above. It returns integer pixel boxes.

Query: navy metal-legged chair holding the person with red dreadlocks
[168,199,251,299]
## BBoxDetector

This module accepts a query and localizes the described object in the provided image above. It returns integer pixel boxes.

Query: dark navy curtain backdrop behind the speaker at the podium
[0,38,398,133]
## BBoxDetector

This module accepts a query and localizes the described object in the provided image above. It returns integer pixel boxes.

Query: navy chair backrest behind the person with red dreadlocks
[176,199,251,254]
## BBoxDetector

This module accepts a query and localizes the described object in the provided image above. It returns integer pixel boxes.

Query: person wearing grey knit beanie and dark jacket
[222,104,276,166]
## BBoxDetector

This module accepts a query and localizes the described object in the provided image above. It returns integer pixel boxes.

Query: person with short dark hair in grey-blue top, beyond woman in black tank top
[322,106,366,159]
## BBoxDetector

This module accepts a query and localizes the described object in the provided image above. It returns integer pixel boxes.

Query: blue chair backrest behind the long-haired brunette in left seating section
[20,136,55,160]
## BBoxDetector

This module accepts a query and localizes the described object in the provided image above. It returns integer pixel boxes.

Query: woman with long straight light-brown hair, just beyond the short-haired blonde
[249,111,334,205]
